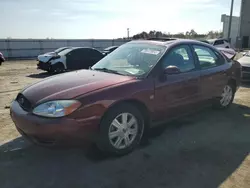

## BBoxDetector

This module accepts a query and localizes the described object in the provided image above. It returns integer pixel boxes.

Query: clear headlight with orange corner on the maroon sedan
[33,100,81,117]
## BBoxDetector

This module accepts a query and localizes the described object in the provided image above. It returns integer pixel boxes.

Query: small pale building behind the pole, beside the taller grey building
[221,14,240,47]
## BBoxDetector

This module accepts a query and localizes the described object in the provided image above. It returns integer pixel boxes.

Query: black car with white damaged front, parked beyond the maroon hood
[37,47,104,73]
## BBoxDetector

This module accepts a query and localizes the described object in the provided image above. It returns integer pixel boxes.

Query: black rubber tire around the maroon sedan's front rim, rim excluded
[97,104,144,155]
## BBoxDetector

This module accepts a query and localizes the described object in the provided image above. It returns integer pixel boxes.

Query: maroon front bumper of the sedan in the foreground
[10,101,99,146]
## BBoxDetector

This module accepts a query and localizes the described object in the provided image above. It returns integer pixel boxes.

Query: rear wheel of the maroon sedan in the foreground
[214,82,236,109]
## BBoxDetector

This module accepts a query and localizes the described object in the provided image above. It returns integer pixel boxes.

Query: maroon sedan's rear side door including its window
[193,45,231,101]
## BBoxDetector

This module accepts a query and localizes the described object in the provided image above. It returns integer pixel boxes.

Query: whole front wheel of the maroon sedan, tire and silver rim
[97,103,144,155]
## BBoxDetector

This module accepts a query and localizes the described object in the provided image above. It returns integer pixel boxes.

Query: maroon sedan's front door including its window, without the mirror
[154,45,201,121]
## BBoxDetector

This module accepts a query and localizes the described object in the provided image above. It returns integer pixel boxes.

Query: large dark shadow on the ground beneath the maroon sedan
[0,104,250,188]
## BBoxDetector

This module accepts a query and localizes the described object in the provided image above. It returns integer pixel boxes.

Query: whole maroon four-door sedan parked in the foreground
[10,40,241,154]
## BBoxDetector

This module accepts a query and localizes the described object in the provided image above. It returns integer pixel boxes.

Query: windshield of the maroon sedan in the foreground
[92,43,166,76]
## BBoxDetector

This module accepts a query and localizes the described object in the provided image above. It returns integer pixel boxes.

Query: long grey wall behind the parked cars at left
[0,39,128,59]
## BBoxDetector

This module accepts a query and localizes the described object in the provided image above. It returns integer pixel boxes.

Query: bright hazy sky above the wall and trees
[0,0,241,39]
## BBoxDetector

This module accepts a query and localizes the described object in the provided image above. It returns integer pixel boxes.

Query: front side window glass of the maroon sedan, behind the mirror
[162,45,195,73]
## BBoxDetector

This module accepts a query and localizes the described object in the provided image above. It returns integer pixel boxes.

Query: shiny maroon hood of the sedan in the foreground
[21,70,134,105]
